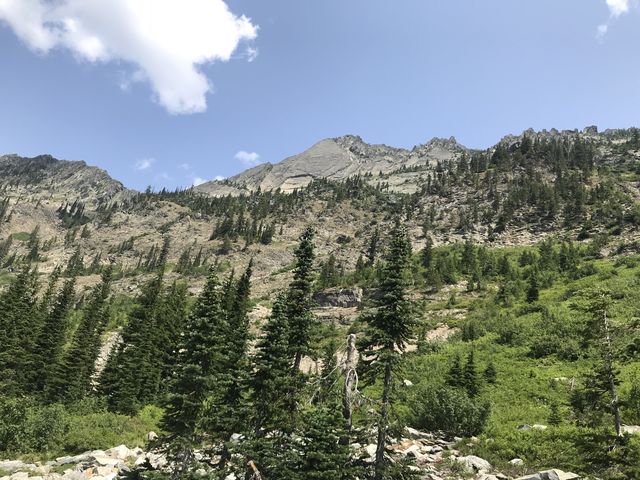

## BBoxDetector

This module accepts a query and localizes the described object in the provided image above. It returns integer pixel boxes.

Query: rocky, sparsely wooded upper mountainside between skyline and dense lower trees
[0,127,640,299]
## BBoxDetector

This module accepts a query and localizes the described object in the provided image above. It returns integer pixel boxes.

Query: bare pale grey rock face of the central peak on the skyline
[197,135,466,196]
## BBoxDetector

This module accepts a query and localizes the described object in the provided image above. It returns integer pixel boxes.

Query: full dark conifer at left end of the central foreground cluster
[163,270,225,478]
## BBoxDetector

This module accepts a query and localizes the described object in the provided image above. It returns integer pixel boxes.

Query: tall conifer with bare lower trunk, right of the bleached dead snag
[363,222,416,480]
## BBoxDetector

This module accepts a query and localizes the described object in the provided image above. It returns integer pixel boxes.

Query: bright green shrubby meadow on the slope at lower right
[405,249,640,478]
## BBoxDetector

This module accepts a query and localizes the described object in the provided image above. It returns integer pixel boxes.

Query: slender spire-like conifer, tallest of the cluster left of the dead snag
[285,228,317,372]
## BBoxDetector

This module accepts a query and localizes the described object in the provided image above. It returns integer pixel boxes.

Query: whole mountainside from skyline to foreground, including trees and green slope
[0,127,640,480]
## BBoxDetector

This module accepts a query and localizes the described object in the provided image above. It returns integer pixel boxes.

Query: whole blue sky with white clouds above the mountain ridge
[0,0,640,189]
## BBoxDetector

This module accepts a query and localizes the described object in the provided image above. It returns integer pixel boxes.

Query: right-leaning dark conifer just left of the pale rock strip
[47,266,113,403]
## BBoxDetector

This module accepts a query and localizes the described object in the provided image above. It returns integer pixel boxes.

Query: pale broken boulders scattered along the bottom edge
[0,428,581,480]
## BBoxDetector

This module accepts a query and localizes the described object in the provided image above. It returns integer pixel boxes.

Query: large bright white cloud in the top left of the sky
[0,0,258,114]
